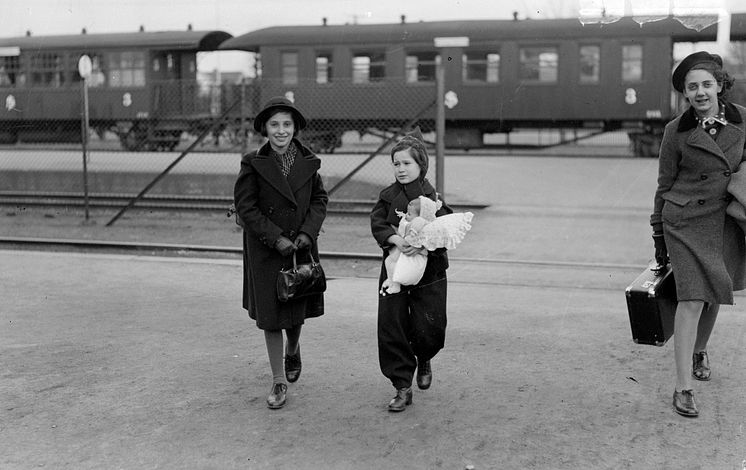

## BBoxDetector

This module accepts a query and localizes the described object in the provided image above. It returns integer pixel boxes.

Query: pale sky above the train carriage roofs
[0,0,746,70]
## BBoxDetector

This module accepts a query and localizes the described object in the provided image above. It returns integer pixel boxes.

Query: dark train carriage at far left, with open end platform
[0,28,232,150]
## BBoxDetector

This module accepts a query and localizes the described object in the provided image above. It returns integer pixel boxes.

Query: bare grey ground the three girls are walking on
[0,250,746,469]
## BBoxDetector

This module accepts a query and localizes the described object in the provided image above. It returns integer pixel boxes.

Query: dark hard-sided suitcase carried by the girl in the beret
[626,261,677,346]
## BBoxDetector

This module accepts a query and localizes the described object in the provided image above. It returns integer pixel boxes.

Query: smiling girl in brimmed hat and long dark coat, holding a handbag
[234,97,328,409]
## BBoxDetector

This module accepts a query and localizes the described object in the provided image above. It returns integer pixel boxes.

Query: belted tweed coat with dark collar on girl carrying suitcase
[650,103,746,304]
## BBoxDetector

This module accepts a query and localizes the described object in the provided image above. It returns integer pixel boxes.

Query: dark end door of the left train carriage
[151,51,183,117]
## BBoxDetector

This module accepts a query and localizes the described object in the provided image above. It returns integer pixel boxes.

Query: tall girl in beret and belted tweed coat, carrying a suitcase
[650,52,746,417]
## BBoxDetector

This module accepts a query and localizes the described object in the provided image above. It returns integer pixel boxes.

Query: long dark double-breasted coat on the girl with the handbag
[234,139,328,330]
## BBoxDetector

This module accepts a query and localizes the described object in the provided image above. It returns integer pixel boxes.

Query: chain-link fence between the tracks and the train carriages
[0,80,628,207]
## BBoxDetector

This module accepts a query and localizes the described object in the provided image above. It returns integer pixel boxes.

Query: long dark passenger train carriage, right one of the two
[220,14,746,156]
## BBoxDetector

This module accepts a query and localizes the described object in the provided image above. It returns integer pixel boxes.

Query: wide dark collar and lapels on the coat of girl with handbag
[251,139,321,204]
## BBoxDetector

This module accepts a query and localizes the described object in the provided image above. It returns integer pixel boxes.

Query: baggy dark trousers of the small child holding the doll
[378,272,448,388]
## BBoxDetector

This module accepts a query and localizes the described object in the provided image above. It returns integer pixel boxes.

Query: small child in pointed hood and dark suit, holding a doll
[370,129,453,411]
